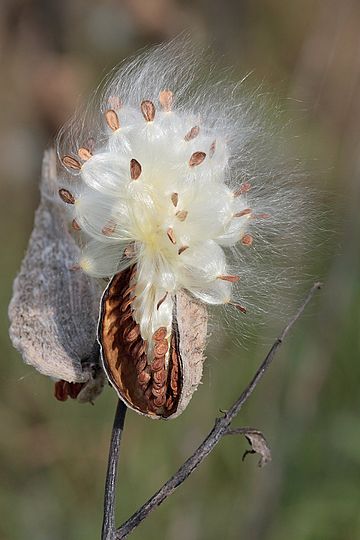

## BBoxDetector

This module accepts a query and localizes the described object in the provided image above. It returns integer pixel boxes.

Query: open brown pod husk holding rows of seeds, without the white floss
[98,267,207,419]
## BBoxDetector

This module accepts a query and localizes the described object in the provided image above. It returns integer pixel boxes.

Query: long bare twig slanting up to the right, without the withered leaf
[112,283,321,540]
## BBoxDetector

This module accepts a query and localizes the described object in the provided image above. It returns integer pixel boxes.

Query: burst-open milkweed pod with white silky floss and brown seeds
[58,39,310,418]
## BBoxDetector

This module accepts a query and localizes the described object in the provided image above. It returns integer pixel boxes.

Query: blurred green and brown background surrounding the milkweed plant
[0,0,360,540]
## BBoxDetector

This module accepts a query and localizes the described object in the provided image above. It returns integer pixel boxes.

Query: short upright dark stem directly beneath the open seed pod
[101,399,126,540]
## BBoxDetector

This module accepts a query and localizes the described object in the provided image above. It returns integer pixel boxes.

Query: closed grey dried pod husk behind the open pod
[9,151,104,401]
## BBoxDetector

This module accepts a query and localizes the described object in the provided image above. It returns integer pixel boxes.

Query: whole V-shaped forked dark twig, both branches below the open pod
[102,283,321,540]
